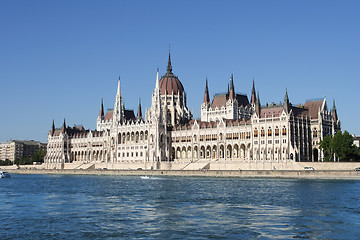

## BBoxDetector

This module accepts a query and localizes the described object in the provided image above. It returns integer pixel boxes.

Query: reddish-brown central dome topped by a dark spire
[159,53,184,95]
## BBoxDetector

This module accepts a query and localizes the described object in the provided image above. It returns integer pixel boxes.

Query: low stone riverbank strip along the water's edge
[9,169,360,180]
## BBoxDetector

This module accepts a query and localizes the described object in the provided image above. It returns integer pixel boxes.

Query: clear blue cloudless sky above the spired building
[0,0,360,142]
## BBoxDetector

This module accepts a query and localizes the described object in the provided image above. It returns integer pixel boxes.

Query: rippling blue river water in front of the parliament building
[0,174,360,239]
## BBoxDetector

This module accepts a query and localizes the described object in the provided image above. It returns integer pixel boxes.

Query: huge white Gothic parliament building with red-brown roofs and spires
[45,54,341,169]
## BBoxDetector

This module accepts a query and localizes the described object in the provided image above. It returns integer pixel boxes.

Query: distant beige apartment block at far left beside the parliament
[0,140,46,162]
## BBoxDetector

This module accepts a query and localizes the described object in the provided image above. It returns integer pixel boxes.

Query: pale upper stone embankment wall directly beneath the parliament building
[4,161,360,171]
